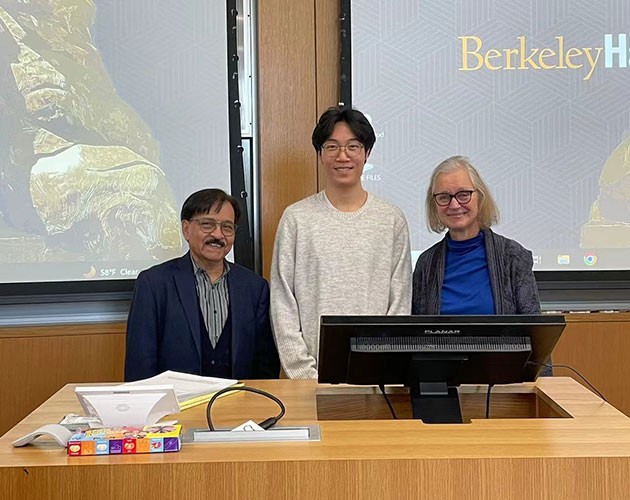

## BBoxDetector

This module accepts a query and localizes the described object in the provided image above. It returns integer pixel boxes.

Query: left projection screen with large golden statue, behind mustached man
[0,0,235,283]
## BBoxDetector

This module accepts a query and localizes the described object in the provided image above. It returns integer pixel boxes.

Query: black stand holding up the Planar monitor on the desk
[409,382,463,424]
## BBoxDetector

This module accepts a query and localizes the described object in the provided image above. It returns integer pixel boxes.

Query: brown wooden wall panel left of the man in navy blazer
[0,323,125,435]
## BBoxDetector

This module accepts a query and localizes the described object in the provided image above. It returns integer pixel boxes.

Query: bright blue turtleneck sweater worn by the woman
[440,232,494,314]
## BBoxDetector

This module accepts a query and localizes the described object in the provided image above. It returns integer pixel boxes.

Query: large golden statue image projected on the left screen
[0,0,182,262]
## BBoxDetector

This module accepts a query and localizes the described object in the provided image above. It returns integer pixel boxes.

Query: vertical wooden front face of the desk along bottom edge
[2,455,630,500]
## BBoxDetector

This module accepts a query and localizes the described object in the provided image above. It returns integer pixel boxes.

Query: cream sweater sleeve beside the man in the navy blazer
[270,212,317,378]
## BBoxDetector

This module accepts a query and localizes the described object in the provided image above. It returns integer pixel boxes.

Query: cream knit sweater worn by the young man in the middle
[270,191,411,378]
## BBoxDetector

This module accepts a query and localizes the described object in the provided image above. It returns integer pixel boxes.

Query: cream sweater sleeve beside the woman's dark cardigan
[387,212,412,315]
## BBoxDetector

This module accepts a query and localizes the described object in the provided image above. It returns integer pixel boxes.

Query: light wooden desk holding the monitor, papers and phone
[0,378,630,500]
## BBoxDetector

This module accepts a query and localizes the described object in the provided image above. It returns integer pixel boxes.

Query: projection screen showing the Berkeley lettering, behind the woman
[342,0,630,271]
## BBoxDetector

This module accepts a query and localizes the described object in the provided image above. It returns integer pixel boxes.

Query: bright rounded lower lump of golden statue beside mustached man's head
[31,145,181,259]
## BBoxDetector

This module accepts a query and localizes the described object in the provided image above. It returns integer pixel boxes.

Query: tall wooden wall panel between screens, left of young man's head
[258,0,317,277]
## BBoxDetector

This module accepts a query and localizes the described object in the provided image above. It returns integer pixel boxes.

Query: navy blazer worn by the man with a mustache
[125,252,280,381]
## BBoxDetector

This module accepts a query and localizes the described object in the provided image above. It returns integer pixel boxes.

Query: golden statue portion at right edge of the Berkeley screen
[581,136,630,248]
